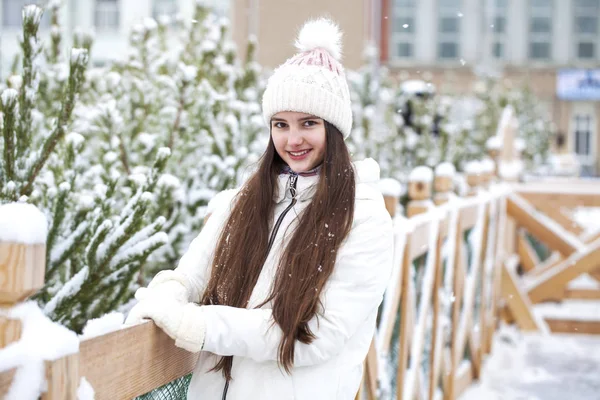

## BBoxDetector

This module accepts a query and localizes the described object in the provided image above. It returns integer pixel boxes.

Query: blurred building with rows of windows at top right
[380,0,600,175]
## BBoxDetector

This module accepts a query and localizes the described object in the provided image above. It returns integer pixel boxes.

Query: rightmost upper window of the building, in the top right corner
[573,0,600,60]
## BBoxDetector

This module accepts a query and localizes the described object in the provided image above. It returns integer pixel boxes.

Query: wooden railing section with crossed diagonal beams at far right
[502,180,600,334]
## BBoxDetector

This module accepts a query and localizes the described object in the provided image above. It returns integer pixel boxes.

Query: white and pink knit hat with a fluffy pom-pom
[263,18,352,139]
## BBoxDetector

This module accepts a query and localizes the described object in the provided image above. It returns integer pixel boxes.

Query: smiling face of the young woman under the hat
[271,111,326,172]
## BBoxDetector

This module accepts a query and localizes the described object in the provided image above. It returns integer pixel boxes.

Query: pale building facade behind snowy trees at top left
[0,0,230,70]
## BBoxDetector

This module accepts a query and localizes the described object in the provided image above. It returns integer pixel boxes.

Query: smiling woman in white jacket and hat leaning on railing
[128,19,393,400]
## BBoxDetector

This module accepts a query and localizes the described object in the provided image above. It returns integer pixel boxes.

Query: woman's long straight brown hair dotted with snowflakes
[201,121,356,380]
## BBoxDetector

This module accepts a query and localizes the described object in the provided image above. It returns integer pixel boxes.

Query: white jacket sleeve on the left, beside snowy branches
[166,190,237,302]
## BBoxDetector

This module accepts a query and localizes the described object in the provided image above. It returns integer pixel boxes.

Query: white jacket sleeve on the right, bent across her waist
[203,201,393,366]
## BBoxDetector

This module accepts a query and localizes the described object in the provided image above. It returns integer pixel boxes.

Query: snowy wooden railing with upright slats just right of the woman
[357,163,509,400]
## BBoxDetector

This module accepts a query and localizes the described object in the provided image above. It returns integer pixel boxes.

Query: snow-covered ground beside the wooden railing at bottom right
[459,327,600,400]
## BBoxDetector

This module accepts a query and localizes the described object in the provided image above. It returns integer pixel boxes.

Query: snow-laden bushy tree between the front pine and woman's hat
[74,4,268,283]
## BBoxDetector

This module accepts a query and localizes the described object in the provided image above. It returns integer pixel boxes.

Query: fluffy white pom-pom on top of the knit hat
[296,18,342,61]
